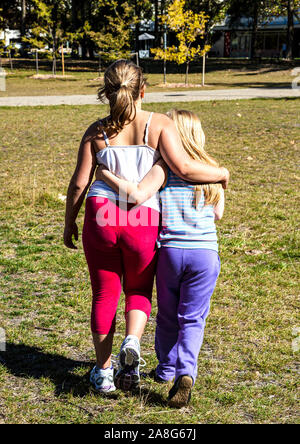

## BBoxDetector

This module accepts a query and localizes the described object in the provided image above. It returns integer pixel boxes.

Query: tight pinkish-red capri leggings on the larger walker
[82,197,159,335]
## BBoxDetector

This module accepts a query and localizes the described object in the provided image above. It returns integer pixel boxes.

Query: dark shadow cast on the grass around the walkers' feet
[0,343,165,405]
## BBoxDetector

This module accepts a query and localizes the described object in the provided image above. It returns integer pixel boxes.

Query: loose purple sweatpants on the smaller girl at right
[155,247,220,382]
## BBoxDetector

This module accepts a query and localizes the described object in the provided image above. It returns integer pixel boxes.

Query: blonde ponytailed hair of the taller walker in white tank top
[98,59,145,134]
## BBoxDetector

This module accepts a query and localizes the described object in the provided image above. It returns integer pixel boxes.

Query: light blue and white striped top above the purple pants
[158,170,218,252]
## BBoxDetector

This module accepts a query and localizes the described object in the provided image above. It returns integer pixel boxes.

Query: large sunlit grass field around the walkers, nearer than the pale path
[0,99,300,424]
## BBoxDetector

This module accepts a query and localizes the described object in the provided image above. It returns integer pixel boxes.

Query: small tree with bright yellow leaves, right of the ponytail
[151,0,210,85]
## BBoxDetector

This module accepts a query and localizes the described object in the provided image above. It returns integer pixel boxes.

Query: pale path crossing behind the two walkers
[0,88,300,106]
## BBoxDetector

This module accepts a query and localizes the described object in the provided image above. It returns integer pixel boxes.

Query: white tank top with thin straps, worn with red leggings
[87,113,161,211]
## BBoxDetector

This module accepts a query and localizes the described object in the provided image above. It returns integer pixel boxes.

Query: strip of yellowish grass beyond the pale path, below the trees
[0,65,293,97]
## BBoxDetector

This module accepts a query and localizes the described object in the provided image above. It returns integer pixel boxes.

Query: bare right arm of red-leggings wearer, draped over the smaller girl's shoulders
[159,117,229,189]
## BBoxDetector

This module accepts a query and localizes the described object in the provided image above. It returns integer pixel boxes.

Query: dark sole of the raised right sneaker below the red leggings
[115,347,140,391]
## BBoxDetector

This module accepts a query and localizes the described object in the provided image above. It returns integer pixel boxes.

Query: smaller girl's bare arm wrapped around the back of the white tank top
[96,159,167,205]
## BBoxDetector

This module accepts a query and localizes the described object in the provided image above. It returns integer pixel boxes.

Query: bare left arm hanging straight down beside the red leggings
[64,129,97,249]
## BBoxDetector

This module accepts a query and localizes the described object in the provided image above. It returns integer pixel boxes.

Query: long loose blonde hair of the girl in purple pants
[167,109,222,208]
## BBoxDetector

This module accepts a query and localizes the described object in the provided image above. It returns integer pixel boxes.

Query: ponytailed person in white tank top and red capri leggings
[64,60,229,393]
